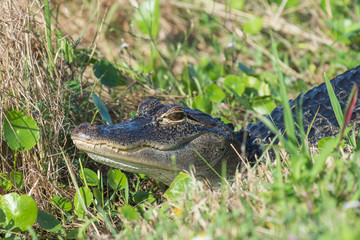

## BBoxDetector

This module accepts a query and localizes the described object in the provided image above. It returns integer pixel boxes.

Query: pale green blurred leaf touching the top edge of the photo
[134,0,160,38]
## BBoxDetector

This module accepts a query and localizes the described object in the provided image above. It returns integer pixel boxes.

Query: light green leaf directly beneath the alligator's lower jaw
[164,172,194,200]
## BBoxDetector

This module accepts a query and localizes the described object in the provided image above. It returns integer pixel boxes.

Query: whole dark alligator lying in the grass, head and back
[71,66,360,185]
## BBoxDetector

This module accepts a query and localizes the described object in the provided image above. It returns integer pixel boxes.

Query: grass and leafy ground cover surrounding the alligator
[0,0,360,239]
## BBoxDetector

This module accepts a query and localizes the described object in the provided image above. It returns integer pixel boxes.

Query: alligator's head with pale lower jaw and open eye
[71,99,242,185]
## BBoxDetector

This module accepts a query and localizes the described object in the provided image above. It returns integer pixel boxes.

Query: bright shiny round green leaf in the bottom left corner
[0,193,38,231]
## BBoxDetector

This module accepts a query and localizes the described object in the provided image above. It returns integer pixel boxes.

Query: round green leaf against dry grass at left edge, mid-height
[3,110,40,151]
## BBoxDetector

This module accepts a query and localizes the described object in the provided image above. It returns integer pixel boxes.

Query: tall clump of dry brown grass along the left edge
[0,0,73,214]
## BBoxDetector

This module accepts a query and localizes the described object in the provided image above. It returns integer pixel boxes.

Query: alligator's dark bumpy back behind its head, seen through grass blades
[246,66,360,161]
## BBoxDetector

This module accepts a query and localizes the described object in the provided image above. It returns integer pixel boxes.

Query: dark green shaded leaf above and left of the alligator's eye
[93,59,126,88]
